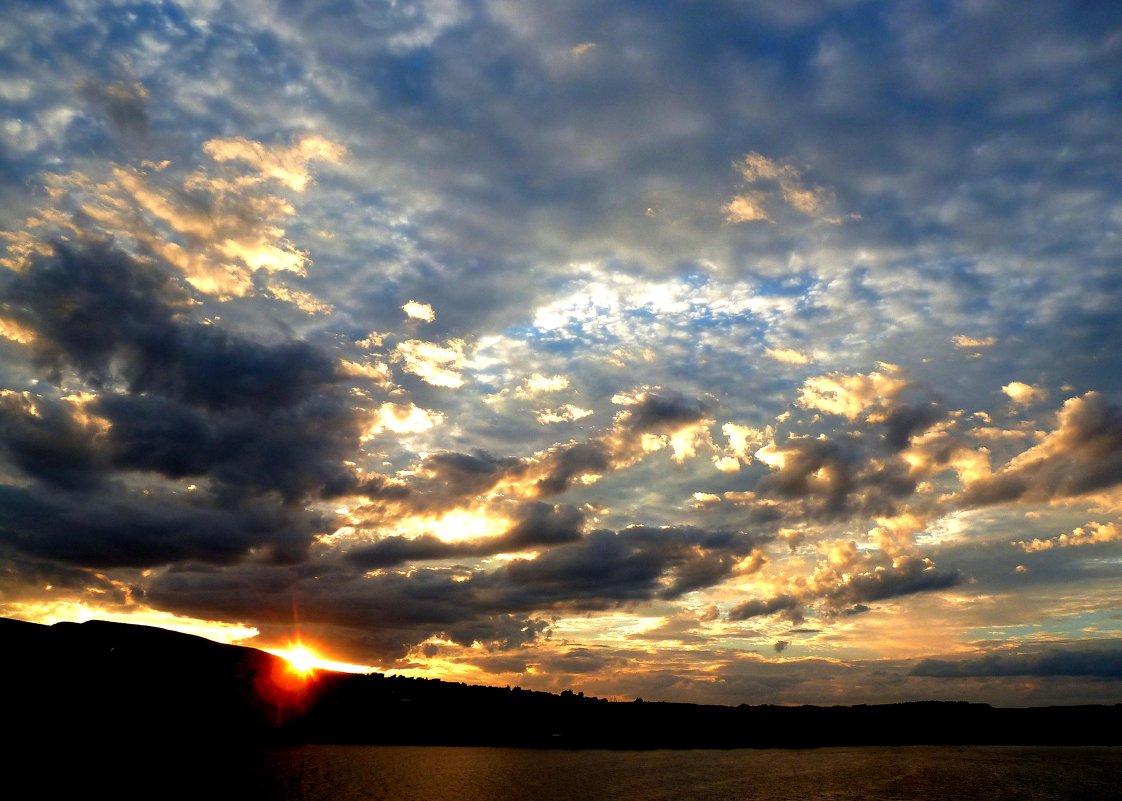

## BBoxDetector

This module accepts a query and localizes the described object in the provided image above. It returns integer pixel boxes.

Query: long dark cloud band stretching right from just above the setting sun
[147,518,762,659]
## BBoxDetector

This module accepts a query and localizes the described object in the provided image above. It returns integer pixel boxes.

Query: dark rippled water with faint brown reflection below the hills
[231,746,1122,801]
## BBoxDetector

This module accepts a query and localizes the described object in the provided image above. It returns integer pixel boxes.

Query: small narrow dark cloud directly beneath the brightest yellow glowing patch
[347,503,585,569]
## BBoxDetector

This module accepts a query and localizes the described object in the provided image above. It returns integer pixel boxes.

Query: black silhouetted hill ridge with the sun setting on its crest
[0,618,1122,748]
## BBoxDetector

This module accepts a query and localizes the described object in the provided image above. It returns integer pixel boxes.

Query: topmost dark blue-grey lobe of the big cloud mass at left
[0,242,339,412]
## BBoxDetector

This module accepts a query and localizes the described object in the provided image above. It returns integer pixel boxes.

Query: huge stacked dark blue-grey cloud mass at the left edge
[0,240,404,567]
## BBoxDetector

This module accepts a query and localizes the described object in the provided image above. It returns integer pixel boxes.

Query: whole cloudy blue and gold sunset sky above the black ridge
[0,0,1122,706]
